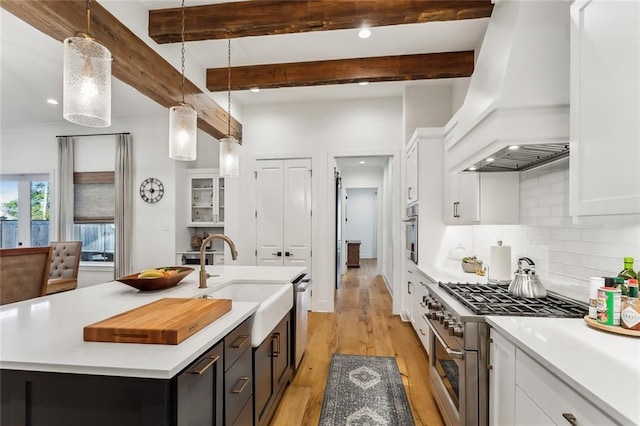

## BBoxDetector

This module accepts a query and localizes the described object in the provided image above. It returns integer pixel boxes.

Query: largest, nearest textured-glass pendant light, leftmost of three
[62,0,111,127]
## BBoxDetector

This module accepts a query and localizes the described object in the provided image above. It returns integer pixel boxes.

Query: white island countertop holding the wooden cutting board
[0,265,306,379]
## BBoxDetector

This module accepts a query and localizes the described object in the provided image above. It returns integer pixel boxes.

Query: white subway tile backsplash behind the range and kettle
[464,159,640,302]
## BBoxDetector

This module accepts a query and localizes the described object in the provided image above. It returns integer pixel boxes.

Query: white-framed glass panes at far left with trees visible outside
[0,174,51,248]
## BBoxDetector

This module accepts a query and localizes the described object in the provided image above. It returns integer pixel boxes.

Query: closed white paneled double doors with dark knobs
[256,159,311,268]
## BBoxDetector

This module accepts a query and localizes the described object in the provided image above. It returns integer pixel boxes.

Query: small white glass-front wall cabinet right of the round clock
[187,169,224,227]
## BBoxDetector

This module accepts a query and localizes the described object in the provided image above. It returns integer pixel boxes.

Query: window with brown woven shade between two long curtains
[73,172,115,262]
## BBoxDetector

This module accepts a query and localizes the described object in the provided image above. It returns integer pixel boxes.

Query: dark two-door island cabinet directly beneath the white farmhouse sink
[253,313,292,426]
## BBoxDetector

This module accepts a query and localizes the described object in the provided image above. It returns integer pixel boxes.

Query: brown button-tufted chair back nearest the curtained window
[47,241,82,294]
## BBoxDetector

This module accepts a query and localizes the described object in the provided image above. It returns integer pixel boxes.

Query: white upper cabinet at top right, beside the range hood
[570,0,640,216]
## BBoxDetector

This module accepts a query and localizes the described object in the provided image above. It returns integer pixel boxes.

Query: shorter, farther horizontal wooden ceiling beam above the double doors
[207,51,474,92]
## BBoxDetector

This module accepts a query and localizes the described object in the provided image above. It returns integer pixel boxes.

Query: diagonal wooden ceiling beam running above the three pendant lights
[0,0,242,140]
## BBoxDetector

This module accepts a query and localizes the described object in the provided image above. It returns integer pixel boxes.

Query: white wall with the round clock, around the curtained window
[0,114,217,287]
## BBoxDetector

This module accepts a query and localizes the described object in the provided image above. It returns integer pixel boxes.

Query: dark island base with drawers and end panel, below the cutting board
[0,318,253,426]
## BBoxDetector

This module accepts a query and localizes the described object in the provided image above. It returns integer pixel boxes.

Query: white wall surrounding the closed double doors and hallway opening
[225,97,403,311]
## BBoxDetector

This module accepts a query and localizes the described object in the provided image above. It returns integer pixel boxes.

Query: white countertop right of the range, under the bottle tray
[487,316,640,425]
